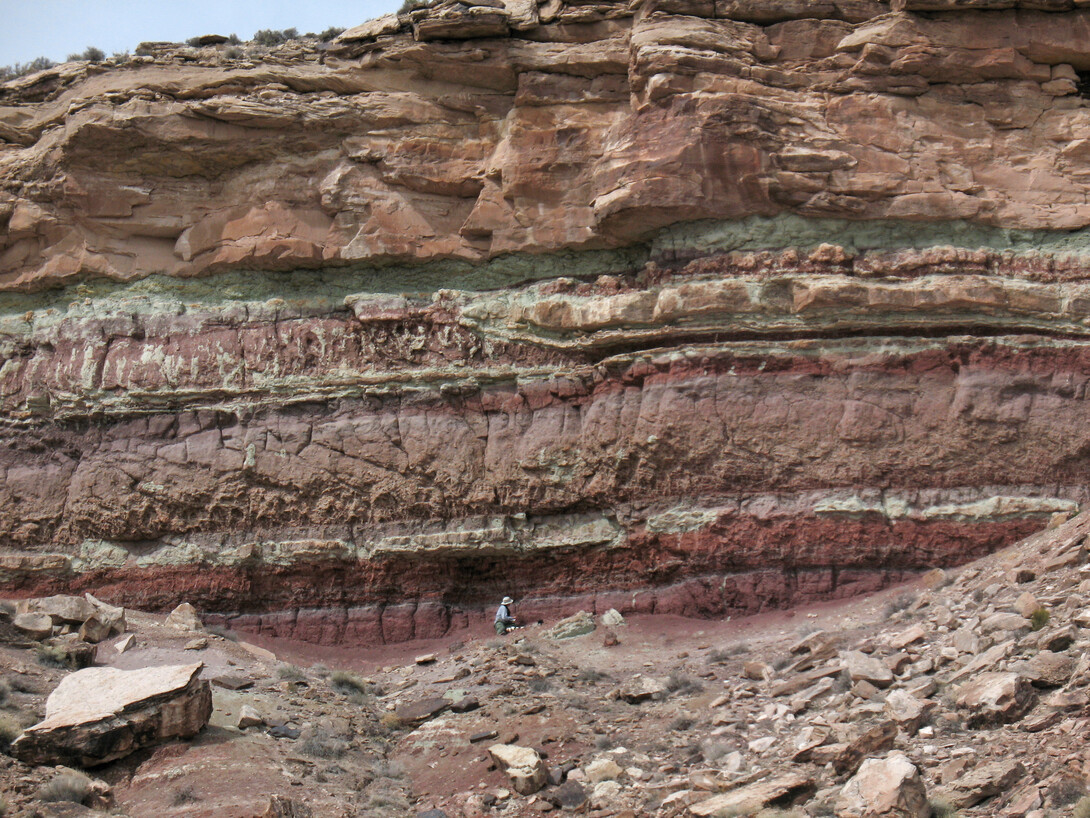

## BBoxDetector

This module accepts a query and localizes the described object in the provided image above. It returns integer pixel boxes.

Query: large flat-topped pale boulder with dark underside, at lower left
[11,662,211,767]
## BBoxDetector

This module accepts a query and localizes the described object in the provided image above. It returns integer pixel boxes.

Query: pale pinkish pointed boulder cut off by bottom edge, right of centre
[836,753,931,818]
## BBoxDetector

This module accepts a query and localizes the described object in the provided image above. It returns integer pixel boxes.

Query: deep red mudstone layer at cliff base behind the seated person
[0,515,1042,645]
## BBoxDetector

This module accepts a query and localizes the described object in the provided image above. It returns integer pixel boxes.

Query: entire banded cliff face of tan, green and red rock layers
[0,0,1090,641]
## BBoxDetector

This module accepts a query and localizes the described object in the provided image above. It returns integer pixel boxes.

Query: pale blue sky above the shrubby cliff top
[0,0,401,65]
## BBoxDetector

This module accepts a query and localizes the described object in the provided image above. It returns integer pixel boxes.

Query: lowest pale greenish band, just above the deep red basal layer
[0,485,1090,581]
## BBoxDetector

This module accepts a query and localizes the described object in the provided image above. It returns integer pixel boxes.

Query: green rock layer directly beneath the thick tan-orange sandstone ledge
[6,215,1090,320]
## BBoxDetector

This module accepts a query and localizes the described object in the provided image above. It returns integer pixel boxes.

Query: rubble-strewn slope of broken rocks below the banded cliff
[0,514,1090,818]
